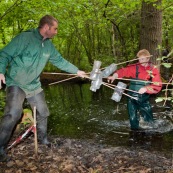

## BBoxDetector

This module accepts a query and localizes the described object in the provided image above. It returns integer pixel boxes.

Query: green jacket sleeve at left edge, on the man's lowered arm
[0,35,23,74]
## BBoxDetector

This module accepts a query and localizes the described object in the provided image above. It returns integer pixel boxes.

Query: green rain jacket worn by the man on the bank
[0,28,78,97]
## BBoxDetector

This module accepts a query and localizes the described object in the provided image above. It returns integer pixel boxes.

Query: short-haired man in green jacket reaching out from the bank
[0,15,85,162]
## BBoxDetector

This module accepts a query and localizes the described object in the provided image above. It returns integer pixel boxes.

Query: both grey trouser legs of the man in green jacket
[0,86,49,148]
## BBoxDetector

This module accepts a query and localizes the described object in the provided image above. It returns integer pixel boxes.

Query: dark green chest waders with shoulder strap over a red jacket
[127,65,153,130]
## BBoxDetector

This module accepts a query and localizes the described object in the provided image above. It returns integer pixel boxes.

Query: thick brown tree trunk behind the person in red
[139,0,162,64]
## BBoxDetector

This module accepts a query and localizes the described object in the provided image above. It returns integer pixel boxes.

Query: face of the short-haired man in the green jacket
[45,21,58,38]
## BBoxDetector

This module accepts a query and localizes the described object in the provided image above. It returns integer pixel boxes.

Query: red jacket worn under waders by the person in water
[116,63,162,94]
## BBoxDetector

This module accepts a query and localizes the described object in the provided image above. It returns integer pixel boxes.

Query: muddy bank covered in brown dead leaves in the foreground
[0,135,173,173]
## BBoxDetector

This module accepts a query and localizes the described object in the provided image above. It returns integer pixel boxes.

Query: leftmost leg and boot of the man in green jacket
[0,86,25,162]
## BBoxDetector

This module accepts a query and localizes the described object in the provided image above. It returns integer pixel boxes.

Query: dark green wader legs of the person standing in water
[127,98,153,129]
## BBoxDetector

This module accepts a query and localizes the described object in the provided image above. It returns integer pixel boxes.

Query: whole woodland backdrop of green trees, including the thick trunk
[0,0,173,102]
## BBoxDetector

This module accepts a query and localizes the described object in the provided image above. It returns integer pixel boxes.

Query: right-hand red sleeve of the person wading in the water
[146,66,162,94]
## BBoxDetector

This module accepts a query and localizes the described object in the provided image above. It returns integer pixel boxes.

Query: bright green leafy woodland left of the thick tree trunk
[0,0,141,69]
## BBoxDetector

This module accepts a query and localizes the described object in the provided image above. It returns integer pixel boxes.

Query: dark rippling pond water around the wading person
[0,83,173,153]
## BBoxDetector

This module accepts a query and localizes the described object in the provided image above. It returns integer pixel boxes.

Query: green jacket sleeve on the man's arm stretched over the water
[49,44,79,74]
